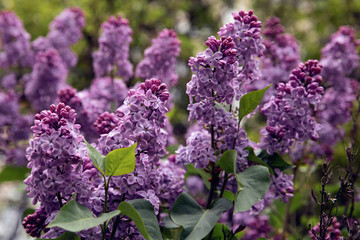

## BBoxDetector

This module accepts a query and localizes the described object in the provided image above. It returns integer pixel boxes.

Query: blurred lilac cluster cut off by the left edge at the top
[0,11,33,68]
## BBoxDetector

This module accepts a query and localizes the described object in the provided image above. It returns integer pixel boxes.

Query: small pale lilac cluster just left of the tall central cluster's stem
[176,130,216,168]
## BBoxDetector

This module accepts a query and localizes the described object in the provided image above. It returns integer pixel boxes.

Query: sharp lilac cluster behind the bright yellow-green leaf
[90,78,184,238]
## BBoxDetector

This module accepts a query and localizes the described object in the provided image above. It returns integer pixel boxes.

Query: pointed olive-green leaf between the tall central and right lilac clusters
[239,84,271,121]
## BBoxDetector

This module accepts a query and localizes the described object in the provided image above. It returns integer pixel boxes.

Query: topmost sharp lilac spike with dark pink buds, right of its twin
[218,10,264,84]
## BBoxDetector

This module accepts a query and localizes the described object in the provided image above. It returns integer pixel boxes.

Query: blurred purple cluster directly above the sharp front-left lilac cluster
[25,48,68,111]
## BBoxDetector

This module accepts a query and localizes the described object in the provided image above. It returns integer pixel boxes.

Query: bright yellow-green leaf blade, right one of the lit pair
[105,143,137,176]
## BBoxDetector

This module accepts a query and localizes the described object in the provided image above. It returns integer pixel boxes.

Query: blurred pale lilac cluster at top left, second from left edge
[33,7,85,68]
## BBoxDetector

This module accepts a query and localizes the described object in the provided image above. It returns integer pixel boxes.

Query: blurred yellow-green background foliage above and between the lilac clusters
[0,0,360,240]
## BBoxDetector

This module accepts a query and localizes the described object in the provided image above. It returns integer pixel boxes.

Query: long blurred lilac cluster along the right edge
[311,26,360,159]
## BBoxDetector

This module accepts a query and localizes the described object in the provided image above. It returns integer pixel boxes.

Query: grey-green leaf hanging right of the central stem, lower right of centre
[234,165,270,214]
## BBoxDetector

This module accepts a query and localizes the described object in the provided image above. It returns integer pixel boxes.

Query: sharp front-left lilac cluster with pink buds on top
[23,103,92,237]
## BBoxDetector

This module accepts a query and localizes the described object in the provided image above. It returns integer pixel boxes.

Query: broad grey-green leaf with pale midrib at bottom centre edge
[170,193,232,240]
